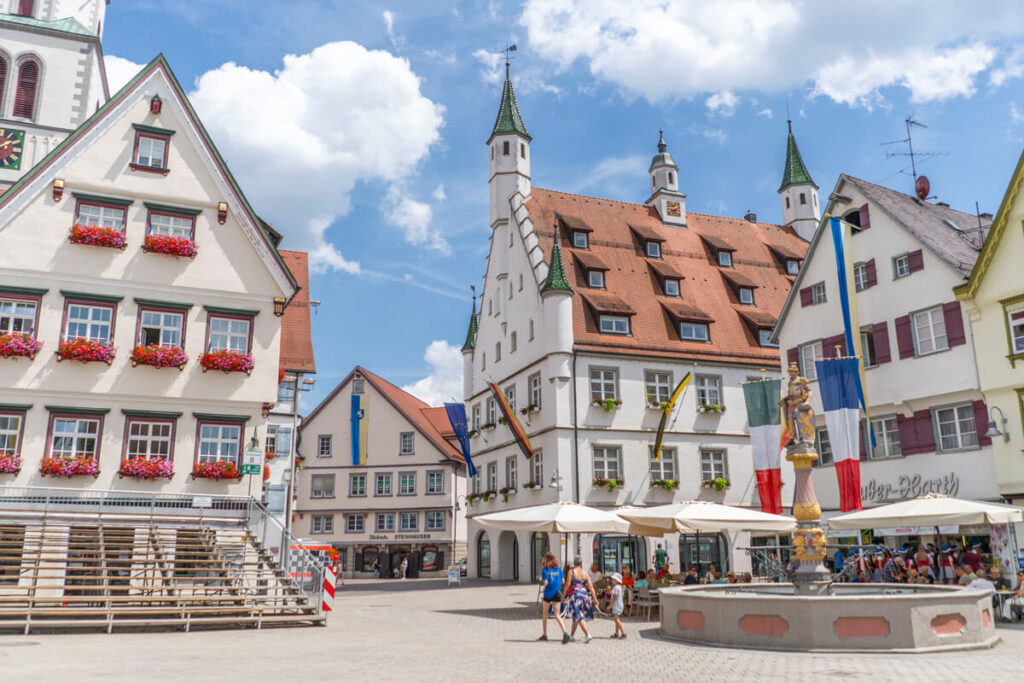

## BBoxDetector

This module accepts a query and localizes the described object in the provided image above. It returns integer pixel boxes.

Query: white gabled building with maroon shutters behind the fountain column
[775,175,999,532]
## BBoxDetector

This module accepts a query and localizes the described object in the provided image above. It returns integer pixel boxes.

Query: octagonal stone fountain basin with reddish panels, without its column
[658,584,999,652]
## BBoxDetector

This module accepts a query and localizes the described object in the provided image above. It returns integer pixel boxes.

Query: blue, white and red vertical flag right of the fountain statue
[814,358,861,512]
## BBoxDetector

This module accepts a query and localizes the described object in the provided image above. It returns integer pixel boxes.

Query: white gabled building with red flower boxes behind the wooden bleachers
[0,56,298,494]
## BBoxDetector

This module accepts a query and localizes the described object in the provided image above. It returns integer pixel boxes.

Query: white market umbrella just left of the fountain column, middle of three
[618,501,797,536]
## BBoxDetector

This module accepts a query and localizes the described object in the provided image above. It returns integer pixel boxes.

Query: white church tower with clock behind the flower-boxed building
[0,0,110,190]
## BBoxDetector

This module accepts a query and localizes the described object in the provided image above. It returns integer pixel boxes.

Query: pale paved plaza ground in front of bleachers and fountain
[6,581,1024,683]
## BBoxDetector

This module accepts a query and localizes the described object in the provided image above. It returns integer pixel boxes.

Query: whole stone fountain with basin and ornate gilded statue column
[658,364,999,652]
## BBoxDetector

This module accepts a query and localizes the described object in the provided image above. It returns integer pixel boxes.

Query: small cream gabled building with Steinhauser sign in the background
[293,367,466,578]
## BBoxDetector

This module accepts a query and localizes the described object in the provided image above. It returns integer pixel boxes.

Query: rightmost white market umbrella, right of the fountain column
[828,494,1024,529]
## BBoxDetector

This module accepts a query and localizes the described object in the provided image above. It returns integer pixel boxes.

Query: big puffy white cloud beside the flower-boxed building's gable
[189,41,444,272]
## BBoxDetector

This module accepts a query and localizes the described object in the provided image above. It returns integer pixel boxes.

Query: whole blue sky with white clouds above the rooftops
[97,0,1024,405]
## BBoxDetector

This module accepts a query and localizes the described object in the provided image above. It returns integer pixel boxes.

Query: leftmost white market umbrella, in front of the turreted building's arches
[473,502,630,533]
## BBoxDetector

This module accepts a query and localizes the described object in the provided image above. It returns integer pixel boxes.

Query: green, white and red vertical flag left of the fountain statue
[743,380,782,515]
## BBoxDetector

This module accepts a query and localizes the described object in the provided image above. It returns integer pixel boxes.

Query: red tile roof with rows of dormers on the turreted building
[525,187,807,366]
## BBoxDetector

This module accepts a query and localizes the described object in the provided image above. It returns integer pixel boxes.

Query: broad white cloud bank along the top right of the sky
[520,0,1024,105]
